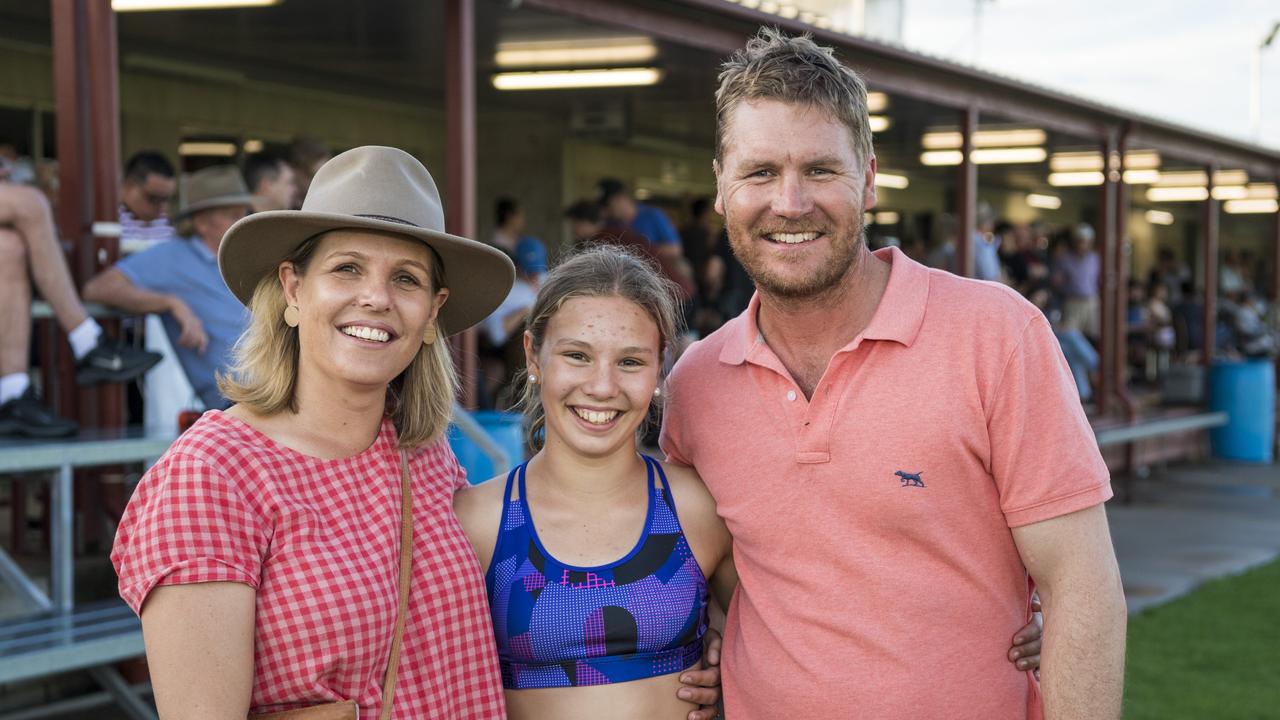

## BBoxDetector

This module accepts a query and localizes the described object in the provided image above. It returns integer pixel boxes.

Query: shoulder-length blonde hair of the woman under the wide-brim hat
[218,233,458,447]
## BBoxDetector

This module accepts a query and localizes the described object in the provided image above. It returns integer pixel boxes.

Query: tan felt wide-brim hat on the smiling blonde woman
[218,145,516,334]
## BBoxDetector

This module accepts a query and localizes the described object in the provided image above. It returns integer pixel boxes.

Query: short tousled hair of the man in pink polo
[716,27,872,161]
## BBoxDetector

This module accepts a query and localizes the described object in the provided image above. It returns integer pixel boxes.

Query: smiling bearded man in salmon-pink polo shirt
[662,31,1125,720]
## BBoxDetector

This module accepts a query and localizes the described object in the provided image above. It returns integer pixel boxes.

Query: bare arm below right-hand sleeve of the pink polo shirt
[1012,505,1128,720]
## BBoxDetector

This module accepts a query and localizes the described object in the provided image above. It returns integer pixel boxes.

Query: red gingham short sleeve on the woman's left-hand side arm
[111,452,270,612]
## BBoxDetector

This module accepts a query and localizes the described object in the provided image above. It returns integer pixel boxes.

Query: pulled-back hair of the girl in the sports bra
[520,245,684,451]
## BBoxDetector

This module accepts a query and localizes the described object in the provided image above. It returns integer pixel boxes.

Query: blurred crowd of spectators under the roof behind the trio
[0,137,1277,437]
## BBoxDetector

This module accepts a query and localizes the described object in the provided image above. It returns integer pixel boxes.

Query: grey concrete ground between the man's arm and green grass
[1107,461,1280,614]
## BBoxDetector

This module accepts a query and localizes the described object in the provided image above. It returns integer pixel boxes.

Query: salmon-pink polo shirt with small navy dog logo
[662,249,1111,720]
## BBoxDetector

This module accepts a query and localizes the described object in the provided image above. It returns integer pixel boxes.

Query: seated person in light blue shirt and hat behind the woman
[84,165,252,409]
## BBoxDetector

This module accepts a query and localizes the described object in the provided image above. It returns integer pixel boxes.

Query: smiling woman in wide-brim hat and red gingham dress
[113,147,515,719]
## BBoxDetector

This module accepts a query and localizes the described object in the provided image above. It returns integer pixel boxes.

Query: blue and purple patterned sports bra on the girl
[485,455,707,689]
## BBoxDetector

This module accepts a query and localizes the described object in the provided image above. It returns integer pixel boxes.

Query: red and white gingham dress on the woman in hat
[111,411,506,719]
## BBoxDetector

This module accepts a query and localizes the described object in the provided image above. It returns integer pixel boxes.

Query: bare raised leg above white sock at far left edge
[0,186,88,332]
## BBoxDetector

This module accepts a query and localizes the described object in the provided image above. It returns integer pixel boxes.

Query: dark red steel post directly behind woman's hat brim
[444,0,479,407]
